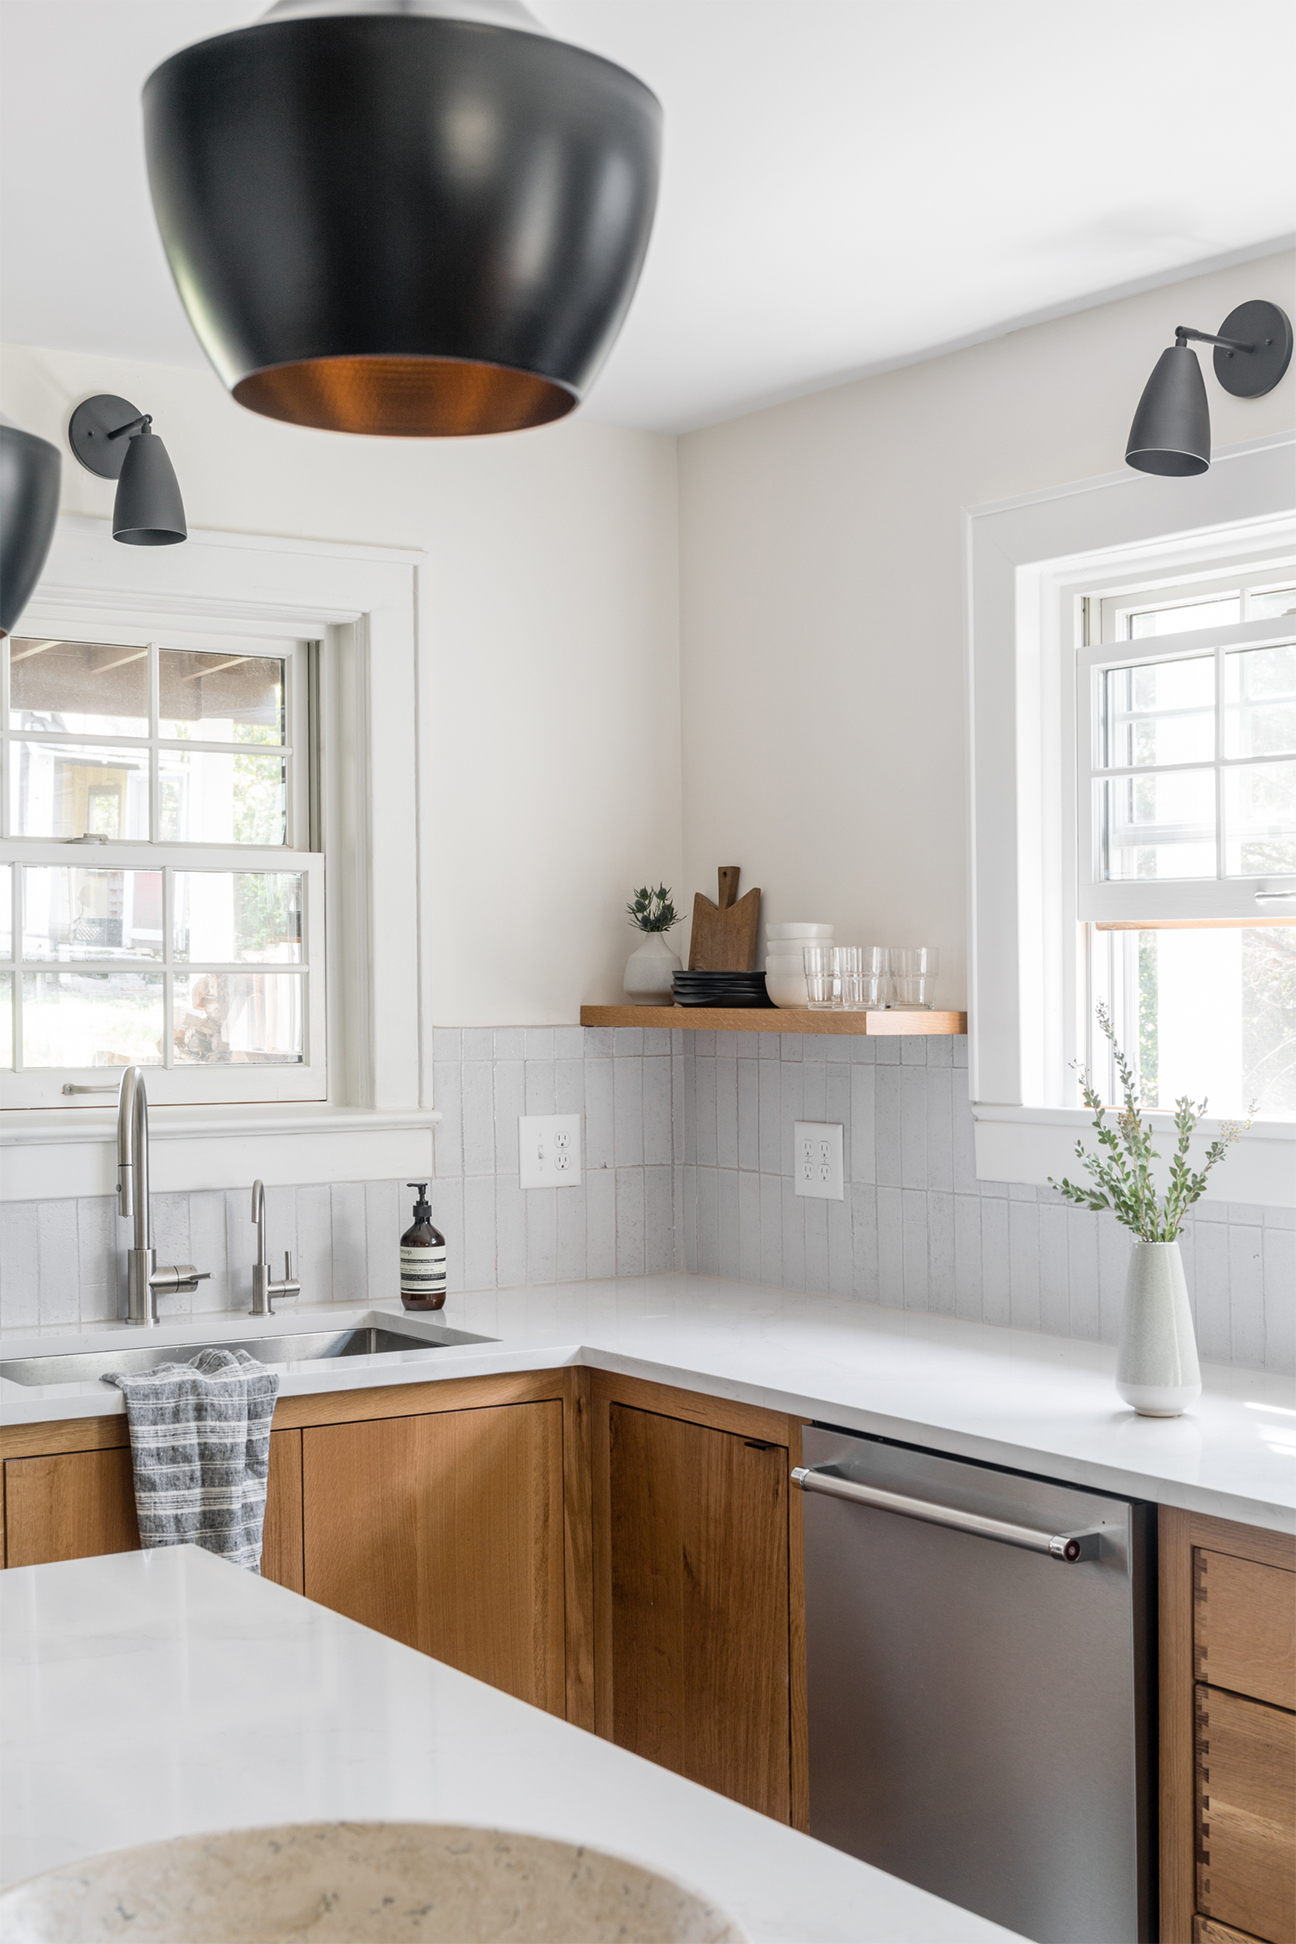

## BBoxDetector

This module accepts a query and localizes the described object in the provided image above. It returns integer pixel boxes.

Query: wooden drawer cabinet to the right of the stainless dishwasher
[1158,1507,1296,1944]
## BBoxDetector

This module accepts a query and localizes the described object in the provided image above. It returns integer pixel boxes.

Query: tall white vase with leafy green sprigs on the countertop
[1049,1005,1251,1417]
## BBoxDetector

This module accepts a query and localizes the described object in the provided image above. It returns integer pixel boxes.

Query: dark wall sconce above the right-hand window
[1125,297,1292,478]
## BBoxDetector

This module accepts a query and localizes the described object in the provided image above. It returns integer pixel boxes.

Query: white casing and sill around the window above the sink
[0,515,439,1201]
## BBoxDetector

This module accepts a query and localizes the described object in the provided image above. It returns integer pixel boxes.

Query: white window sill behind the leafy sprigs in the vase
[972,1104,1296,1207]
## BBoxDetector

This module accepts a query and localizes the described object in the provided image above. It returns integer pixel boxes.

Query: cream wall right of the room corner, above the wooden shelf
[680,255,1296,1005]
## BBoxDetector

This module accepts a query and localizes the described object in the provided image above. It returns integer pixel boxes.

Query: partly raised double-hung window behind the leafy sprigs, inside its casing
[1076,560,1296,1120]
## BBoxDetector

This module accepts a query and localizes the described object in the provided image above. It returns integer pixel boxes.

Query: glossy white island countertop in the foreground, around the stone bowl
[0,1545,1014,1944]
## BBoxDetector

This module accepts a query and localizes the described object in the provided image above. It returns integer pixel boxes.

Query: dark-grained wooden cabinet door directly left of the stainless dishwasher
[597,1404,791,1822]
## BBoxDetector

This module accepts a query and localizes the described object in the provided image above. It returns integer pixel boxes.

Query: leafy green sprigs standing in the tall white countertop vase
[1049,1005,1251,1242]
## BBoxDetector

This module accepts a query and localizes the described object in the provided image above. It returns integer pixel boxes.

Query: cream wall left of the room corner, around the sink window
[0,346,682,1026]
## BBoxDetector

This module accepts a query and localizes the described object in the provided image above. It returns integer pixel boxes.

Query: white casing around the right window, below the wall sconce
[964,434,1296,1207]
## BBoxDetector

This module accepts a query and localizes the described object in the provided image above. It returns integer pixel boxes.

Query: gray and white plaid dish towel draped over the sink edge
[103,1349,280,1573]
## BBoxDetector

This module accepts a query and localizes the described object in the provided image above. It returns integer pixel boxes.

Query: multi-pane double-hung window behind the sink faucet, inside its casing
[0,616,326,1106]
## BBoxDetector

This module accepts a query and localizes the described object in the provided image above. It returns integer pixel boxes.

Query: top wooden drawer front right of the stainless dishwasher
[1193,1545,1296,1709]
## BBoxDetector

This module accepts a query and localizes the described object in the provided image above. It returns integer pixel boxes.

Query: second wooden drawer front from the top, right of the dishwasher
[1197,1687,1296,1944]
